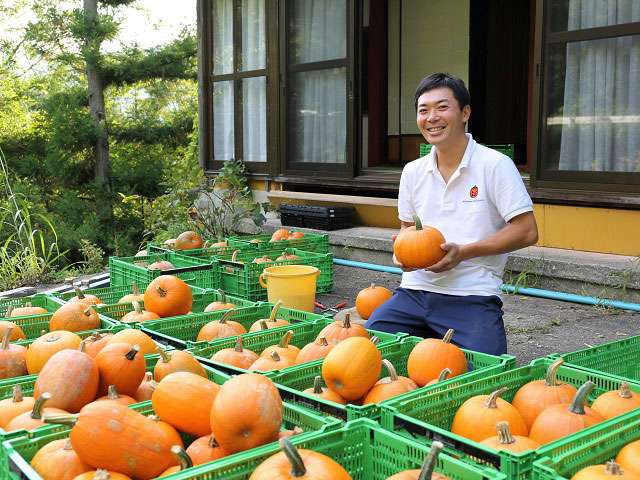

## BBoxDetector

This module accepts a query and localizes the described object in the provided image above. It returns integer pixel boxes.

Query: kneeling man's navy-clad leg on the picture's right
[427,292,507,355]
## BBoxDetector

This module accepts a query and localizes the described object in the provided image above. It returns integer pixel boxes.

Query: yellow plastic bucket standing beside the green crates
[260,265,320,312]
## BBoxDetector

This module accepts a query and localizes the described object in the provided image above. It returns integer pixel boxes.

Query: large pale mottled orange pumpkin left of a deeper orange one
[33,350,99,413]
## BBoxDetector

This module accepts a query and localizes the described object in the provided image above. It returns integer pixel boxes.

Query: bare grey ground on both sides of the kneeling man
[318,265,640,365]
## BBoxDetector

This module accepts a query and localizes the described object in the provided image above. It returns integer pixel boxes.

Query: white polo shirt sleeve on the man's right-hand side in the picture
[492,155,533,222]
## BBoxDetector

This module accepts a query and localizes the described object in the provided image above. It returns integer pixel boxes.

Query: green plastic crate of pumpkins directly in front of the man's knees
[271,337,516,420]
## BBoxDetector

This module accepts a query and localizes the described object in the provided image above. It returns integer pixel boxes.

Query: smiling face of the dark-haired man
[417,87,471,146]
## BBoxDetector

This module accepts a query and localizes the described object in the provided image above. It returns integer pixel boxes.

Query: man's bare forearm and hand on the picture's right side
[427,212,538,273]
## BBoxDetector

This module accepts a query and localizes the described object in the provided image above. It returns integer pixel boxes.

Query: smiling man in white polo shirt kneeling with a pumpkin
[366,73,538,355]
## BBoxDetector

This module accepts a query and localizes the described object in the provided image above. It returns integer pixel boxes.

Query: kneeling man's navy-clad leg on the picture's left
[365,288,435,338]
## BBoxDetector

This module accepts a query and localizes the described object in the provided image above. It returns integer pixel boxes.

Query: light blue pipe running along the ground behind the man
[333,258,640,312]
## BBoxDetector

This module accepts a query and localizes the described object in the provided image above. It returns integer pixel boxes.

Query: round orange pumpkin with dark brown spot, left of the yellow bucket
[144,275,193,318]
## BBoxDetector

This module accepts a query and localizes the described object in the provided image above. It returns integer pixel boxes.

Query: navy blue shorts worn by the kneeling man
[365,288,507,355]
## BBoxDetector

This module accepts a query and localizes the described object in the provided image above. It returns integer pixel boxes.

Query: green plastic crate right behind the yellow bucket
[216,248,333,301]
